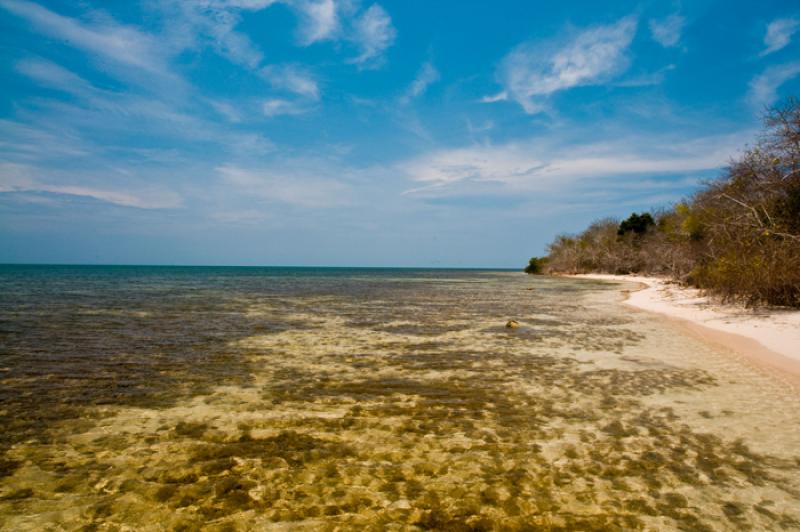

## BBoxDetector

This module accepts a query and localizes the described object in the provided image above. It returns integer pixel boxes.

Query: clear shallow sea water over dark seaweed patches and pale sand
[0,266,800,530]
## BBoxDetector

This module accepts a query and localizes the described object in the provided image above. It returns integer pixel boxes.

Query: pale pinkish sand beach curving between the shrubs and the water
[572,274,800,389]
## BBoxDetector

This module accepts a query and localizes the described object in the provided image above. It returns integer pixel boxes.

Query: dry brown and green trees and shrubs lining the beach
[529,99,800,307]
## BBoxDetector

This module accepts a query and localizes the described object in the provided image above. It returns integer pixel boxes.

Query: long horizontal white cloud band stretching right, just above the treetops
[401,133,744,193]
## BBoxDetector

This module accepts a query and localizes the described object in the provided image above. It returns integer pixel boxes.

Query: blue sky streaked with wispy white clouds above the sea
[0,0,800,268]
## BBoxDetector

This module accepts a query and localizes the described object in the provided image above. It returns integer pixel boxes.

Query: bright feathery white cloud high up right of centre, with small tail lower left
[484,17,637,113]
